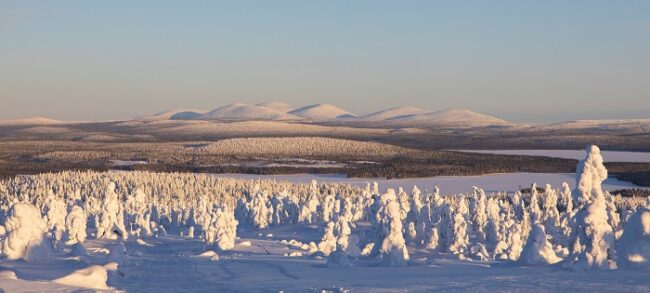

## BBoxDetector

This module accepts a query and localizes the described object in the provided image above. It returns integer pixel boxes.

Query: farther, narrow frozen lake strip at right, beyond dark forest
[455,150,650,163]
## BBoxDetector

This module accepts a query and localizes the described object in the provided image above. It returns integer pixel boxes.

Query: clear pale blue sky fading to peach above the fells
[0,0,650,122]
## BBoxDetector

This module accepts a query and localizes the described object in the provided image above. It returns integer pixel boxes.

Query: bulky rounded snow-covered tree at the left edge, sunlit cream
[3,203,53,262]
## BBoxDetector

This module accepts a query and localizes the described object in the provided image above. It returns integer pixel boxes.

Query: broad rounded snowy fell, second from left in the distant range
[196,103,299,120]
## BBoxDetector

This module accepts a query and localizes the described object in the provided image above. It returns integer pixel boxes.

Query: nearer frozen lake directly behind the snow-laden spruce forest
[214,173,638,193]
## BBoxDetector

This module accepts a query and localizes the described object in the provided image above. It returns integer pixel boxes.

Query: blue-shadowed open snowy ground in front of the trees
[5,225,650,292]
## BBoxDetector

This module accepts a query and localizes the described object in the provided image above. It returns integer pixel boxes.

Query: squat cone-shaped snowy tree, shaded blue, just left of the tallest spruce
[517,224,562,265]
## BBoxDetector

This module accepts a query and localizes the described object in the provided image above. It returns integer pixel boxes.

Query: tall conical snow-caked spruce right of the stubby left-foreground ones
[95,182,128,240]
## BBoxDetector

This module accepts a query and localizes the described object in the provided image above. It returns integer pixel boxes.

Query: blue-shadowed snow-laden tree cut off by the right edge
[616,208,650,270]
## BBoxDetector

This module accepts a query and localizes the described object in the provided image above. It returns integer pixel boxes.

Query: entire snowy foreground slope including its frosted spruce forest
[0,146,650,292]
